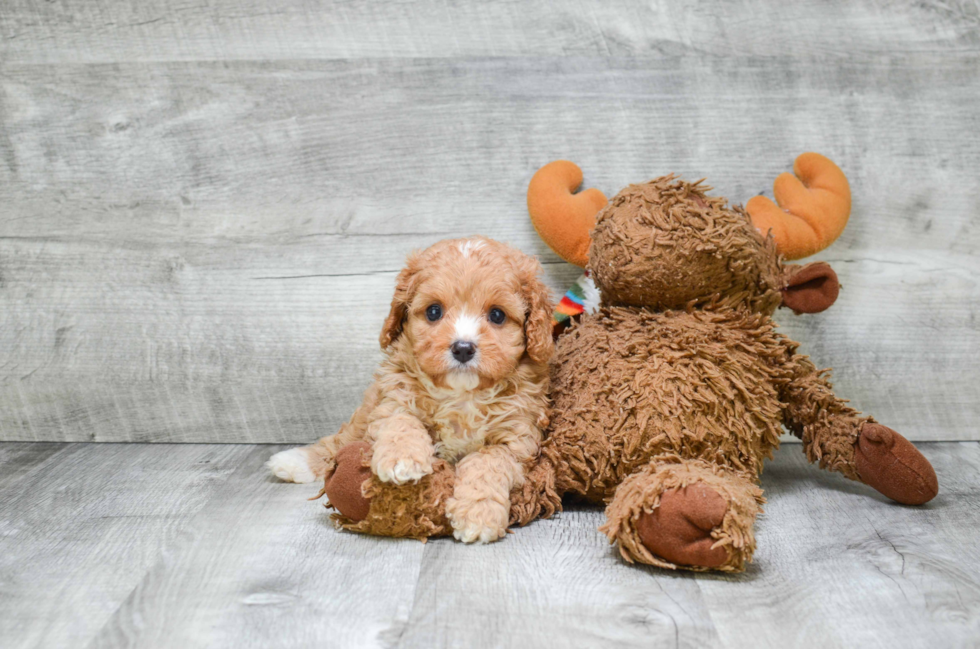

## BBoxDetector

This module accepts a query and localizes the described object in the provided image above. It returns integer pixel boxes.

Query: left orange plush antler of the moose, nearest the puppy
[527,160,607,266]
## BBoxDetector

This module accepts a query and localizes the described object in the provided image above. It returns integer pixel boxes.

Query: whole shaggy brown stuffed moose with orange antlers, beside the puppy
[322,153,938,571]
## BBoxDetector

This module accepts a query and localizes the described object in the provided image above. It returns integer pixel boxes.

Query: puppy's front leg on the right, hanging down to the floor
[446,446,524,543]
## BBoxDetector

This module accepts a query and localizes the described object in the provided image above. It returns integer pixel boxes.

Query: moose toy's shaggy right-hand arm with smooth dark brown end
[783,356,939,505]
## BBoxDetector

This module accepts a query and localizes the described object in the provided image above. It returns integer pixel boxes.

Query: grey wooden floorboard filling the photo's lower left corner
[0,444,250,647]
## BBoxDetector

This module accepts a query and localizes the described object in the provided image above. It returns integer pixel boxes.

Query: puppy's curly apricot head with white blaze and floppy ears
[381,237,554,390]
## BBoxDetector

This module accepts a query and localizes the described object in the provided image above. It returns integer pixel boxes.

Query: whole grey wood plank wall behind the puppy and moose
[0,0,980,442]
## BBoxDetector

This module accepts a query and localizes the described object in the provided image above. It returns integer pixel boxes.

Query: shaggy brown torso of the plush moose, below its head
[542,307,792,502]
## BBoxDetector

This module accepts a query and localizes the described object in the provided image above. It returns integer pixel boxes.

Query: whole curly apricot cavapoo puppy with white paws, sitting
[269,237,554,543]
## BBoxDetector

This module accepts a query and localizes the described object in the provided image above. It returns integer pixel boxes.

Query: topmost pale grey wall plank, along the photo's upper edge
[0,0,980,63]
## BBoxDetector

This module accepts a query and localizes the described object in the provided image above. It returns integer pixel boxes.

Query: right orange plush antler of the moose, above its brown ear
[745,153,851,259]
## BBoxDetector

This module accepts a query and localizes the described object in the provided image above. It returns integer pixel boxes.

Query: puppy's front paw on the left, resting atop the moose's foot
[367,414,435,485]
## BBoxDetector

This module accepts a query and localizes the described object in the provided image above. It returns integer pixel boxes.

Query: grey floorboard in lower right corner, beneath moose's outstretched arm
[698,443,980,649]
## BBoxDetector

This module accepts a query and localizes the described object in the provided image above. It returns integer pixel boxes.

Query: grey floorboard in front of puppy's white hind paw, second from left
[91,446,423,647]
